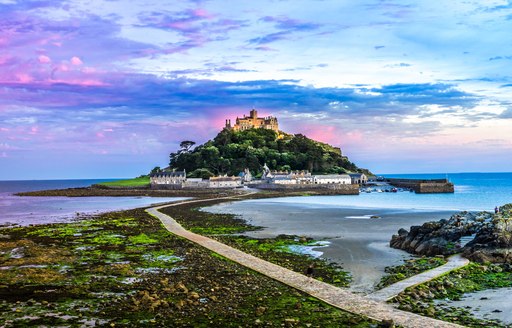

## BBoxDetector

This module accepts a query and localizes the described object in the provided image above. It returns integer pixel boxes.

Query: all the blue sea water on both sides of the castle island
[0,172,512,225]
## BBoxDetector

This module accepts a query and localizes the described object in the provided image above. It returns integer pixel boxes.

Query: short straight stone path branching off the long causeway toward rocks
[366,254,469,302]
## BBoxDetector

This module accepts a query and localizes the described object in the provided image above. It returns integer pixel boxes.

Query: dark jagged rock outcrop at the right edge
[390,205,512,263]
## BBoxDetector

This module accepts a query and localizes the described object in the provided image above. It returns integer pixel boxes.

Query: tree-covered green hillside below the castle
[169,129,367,178]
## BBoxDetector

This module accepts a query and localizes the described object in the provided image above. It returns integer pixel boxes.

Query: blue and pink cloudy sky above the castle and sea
[0,0,512,180]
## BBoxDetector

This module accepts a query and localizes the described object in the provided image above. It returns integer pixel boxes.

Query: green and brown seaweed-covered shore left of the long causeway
[0,209,377,327]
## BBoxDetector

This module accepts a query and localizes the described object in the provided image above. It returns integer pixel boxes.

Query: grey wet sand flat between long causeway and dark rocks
[204,198,455,293]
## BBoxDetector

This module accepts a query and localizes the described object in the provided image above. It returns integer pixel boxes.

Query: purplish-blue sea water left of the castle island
[0,179,188,225]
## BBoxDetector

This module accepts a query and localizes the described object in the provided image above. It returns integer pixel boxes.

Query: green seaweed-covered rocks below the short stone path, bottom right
[393,263,512,327]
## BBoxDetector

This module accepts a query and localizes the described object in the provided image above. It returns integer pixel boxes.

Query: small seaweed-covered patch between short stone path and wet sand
[377,257,446,289]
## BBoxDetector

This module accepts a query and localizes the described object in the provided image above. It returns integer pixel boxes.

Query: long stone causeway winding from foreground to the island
[146,196,461,328]
